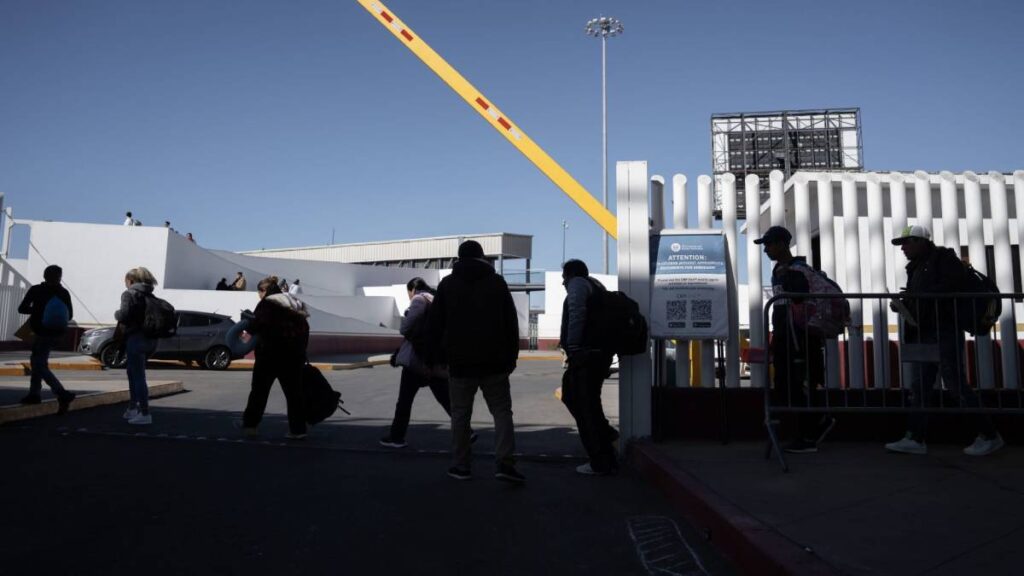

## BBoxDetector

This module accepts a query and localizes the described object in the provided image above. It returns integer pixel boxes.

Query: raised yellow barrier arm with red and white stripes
[357,0,618,238]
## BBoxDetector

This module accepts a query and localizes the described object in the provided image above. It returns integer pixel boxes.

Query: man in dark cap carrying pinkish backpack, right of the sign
[754,227,836,454]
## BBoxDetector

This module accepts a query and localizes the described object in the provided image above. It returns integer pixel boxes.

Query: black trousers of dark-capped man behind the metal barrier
[771,326,824,441]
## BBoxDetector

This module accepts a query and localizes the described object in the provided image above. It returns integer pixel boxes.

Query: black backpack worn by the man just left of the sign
[587,281,649,356]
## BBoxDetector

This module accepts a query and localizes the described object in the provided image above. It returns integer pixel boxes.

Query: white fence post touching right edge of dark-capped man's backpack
[842,174,864,388]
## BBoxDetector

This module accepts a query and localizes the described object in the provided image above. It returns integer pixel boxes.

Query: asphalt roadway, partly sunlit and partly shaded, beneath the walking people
[0,361,733,575]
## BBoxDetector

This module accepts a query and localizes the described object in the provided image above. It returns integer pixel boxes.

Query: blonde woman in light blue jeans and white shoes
[114,266,157,425]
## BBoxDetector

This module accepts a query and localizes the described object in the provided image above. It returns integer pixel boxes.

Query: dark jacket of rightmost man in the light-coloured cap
[902,245,967,341]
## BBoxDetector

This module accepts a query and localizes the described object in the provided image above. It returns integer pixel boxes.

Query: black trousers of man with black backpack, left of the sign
[562,352,618,472]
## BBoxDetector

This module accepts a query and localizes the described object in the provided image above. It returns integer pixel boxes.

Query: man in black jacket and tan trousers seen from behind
[428,240,525,483]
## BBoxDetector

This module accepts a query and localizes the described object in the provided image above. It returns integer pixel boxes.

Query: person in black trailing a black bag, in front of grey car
[242,276,309,440]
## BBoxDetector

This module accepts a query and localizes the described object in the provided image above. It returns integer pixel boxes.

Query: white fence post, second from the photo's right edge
[988,171,1018,388]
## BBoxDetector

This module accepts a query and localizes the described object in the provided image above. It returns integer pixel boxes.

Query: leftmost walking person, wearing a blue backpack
[17,265,75,414]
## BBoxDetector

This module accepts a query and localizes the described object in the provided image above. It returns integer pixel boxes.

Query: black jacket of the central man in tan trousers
[427,259,519,378]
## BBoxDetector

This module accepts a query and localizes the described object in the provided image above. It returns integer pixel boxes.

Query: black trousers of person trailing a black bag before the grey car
[242,349,306,434]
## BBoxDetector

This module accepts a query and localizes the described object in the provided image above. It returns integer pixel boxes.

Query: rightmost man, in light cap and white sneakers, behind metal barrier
[886,224,1004,456]
